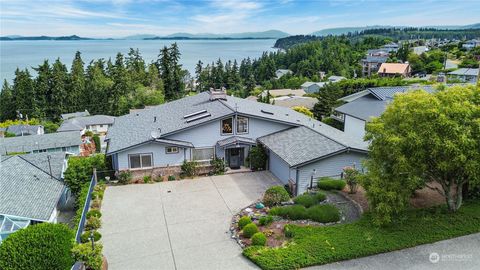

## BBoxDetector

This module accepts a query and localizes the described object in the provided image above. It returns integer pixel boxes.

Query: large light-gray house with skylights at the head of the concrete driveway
[106,91,367,194]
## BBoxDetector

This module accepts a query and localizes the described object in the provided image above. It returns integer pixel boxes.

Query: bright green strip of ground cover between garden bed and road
[243,201,480,269]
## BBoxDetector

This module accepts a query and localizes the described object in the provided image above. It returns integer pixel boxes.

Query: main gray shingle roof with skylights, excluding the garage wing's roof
[107,92,367,154]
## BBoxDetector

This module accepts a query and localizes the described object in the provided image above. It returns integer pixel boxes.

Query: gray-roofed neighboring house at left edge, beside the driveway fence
[0,152,70,243]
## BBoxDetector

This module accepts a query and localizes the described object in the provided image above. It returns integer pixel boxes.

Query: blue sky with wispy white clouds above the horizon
[0,0,480,37]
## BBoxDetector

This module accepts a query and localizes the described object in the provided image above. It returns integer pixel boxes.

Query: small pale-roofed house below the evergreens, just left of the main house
[57,115,115,135]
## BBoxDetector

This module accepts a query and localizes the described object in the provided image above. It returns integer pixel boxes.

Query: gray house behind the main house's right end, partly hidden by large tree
[332,85,435,139]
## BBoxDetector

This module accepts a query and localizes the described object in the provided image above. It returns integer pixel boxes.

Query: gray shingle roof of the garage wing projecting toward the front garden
[258,127,348,167]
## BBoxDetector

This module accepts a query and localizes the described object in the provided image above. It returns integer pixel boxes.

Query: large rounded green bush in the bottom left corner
[0,223,74,270]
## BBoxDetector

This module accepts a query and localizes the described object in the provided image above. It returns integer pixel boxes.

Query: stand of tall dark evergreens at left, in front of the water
[0,43,188,121]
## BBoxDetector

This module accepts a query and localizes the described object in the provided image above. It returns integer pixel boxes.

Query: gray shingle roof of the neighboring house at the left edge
[0,153,65,220]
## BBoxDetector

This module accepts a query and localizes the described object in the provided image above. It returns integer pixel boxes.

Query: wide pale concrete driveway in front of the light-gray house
[101,172,280,270]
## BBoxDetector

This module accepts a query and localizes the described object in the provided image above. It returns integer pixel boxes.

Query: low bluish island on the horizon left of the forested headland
[145,30,289,40]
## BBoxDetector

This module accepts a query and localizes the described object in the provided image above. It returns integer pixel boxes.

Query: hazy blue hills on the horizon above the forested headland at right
[311,23,480,36]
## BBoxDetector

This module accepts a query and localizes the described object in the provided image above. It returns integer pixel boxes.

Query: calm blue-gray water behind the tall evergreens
[0,39,275,82]
